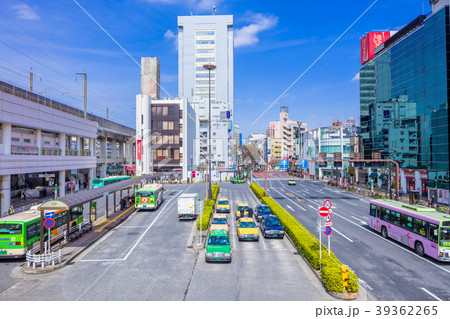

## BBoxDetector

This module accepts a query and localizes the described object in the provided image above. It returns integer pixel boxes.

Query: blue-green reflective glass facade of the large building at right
[360,7,450,189]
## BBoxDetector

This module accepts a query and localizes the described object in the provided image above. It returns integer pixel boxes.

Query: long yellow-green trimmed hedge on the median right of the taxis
[250,183,359,292]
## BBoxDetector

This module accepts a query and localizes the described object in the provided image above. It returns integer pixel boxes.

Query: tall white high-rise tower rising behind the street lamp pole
[178,15,234,170]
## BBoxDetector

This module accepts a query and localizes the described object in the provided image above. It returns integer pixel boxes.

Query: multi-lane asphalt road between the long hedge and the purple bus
[256,174,450,301]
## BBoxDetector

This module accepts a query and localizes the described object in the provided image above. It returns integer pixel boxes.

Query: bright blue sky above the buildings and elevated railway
[0,0,431,137]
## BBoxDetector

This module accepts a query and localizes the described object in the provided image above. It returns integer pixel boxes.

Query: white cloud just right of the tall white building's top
[234,13,278,48]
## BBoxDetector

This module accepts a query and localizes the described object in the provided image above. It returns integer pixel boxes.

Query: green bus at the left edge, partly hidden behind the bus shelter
[0,206,83,258]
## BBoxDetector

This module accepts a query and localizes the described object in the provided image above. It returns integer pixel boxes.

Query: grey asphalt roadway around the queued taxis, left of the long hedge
[0,183,335,301]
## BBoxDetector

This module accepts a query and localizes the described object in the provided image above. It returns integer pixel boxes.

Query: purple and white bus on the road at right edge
[369,199,450,262]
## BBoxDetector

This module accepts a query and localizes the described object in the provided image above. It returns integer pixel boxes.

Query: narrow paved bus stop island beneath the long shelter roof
[23,205,135,274]
